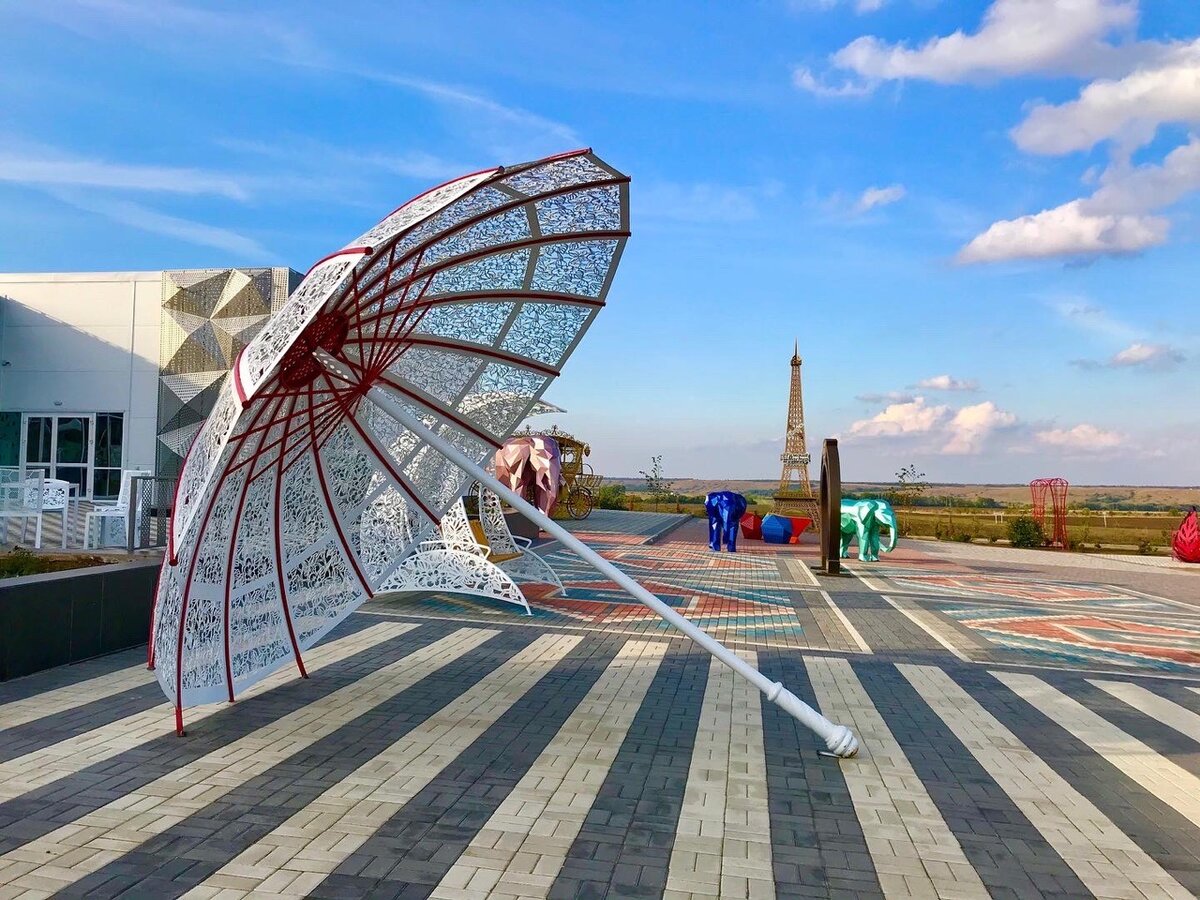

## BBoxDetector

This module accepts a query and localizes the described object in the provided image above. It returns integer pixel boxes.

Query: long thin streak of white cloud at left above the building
[0,148,248,200]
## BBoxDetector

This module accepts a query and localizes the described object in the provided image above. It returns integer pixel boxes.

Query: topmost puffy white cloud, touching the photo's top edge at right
[820,0,1138,86]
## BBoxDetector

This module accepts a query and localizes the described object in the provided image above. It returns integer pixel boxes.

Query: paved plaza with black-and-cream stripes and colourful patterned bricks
[0,510,1200,900]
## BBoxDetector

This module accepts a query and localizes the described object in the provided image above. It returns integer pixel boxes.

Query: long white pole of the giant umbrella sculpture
[368,385,858,756]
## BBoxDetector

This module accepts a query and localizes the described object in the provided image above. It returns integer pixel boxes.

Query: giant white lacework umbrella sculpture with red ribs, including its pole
[150,150,858,756]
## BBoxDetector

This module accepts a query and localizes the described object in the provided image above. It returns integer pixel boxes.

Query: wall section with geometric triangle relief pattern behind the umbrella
[155,266,301,479]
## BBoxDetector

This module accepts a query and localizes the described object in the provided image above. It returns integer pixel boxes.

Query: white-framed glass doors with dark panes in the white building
[20,413,104,498]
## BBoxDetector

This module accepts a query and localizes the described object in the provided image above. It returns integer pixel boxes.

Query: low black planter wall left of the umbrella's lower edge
[0,559,158,682]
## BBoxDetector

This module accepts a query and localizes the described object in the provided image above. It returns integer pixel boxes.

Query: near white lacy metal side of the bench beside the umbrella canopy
[380,498,533,616]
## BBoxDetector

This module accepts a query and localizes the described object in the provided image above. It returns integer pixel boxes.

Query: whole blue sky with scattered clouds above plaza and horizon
[0,0,1200,484]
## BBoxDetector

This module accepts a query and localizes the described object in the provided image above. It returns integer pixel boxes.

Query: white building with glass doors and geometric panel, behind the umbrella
[0,268,300,499]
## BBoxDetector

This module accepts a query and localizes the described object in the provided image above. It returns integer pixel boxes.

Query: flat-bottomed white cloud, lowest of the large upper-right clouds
[958,200,1170,263]
